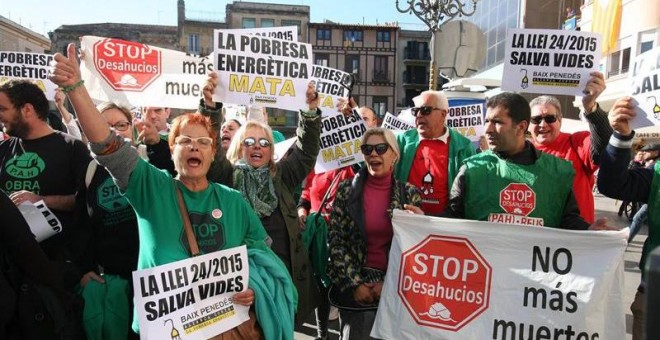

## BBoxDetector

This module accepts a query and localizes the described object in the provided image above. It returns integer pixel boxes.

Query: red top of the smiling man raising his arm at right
[534,131,598,223]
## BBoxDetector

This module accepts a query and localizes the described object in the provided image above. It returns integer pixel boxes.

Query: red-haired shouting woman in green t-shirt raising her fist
[50,44,296,338]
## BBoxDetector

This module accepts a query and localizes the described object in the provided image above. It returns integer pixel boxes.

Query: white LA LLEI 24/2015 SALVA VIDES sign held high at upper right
[502,29,601,96]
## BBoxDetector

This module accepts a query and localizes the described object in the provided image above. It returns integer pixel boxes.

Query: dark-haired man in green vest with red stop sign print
[446,93,602,230]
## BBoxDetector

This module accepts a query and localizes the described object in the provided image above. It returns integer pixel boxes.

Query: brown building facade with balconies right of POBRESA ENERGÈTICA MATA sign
[307,22,401,118]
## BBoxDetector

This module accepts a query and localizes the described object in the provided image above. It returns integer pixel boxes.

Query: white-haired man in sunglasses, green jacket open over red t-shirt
[396,91,475,215]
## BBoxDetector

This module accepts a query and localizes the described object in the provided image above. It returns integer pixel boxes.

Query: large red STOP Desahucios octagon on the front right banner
[397,235,492,331]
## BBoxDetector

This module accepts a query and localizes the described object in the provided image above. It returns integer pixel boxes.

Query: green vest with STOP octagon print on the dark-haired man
[464,151,575,228]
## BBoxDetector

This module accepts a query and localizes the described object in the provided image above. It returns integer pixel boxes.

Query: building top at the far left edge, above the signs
[0,15,50,53]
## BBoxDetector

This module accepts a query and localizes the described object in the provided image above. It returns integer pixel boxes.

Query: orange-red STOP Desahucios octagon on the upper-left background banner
[94,39,161,92]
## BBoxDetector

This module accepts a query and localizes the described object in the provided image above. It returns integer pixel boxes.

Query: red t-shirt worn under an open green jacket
[408,139,449,215]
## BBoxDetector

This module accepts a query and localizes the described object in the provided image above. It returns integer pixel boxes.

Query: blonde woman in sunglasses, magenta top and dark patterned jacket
[327,128,423,340]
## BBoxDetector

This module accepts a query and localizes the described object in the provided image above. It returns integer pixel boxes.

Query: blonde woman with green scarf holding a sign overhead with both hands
[203,74,321,324]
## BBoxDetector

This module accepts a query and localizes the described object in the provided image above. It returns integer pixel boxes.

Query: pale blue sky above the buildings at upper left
[5,0,426,36]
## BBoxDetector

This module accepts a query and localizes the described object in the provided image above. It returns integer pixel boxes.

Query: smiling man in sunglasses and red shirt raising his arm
[529,72,612,223]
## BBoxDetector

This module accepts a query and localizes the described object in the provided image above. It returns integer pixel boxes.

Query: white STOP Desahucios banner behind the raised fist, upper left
[80,36,213,109]
